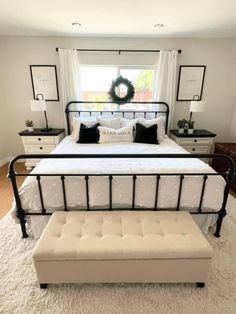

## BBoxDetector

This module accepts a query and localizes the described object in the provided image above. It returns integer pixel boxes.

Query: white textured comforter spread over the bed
[20,136,225,211]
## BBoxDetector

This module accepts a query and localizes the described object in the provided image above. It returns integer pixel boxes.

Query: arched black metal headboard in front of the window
[65,100,169,134]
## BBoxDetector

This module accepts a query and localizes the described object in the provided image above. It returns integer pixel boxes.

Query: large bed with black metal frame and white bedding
[9,102,234,237]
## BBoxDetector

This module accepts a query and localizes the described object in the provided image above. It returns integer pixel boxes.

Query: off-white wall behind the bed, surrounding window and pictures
[0,37,236,158]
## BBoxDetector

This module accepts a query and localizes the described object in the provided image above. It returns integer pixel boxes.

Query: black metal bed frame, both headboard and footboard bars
[8,102,234,238]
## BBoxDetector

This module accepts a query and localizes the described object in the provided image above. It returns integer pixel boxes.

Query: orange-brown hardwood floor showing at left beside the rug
[0,162,29,219]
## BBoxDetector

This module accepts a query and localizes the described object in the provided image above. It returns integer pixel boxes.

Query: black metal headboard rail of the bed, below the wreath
[65,100,170,134]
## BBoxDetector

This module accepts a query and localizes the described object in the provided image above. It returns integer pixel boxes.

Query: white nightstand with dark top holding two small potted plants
[170,130,216,162]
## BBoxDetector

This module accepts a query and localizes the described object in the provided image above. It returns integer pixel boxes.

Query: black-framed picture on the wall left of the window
[30,64,60,101]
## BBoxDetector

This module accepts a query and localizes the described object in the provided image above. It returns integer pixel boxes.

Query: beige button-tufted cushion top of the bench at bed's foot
[33,211,213,261]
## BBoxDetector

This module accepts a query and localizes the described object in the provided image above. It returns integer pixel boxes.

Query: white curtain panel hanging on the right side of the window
[153,50,178,128]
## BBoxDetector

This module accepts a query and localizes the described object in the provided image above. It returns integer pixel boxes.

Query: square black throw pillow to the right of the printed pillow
[134,123,159,144]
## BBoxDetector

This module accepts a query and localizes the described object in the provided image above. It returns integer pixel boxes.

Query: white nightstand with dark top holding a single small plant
[19,129,65,170]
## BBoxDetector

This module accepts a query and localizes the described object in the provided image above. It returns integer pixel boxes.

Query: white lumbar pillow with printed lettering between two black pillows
[98,125,133,143]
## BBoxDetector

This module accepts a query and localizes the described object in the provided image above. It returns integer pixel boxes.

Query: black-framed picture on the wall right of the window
[176,65,206,101]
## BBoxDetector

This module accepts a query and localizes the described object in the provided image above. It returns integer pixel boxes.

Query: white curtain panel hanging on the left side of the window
[58,48,81,125]
